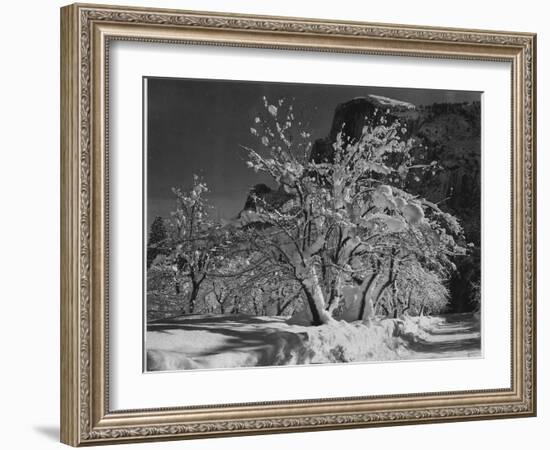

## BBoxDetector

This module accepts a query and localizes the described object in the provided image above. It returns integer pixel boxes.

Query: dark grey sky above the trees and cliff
[145,78,479,227]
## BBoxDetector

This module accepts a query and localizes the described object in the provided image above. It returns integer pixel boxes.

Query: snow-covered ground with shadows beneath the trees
[146,314,481,371]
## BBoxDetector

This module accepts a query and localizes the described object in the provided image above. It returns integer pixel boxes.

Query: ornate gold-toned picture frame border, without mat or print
[61,4,536,446]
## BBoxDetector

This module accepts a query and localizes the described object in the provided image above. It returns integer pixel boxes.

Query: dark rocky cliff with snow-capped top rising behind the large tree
[310,95,481,214]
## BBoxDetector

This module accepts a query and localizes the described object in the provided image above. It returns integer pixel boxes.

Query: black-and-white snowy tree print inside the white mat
[143,77,482,372]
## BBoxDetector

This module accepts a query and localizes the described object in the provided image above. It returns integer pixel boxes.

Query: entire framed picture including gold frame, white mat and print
[61,4,536,446]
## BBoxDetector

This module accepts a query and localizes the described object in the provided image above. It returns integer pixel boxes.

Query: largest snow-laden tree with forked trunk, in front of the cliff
[241,97,463,325]
